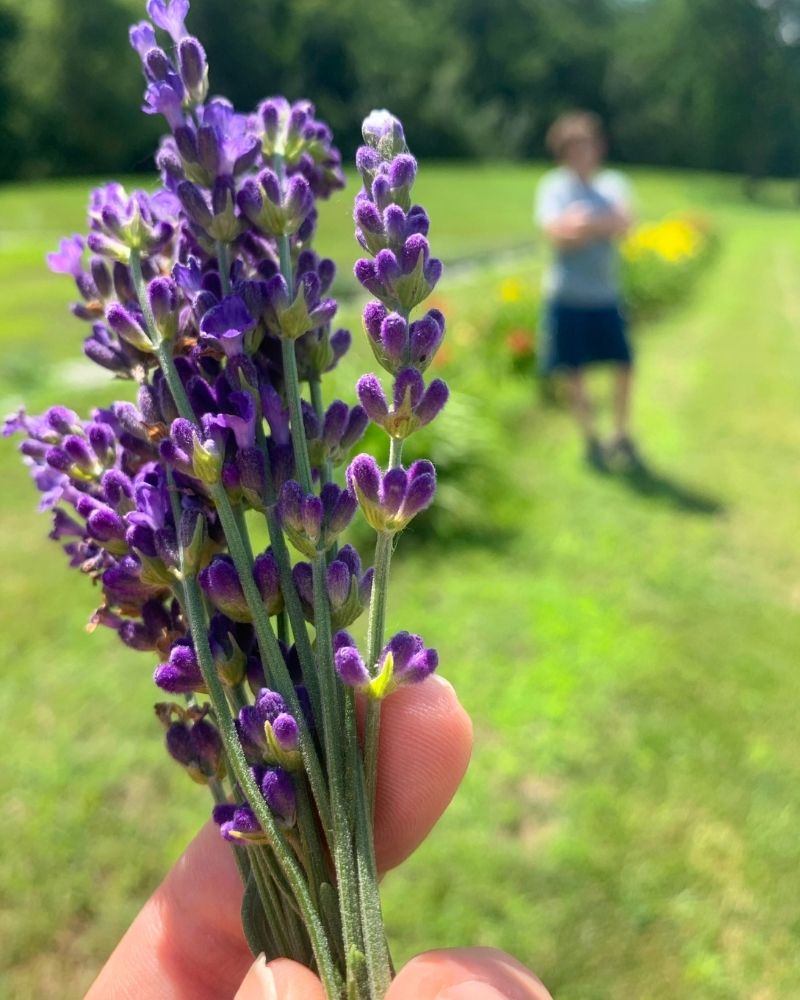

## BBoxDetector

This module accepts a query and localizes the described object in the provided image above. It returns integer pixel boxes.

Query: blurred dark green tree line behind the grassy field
[0,0,800,179]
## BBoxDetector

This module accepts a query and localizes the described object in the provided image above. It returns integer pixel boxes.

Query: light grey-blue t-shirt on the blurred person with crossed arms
[534,167,630,308]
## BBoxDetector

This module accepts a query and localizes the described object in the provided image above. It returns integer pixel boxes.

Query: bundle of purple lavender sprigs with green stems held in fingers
[1,0,447,1000]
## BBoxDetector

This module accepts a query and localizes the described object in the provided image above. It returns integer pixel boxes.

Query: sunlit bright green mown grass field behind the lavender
[0,166,800,1000]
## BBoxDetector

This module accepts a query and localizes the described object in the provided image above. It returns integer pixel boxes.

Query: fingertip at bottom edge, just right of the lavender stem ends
[386,948,552,1000]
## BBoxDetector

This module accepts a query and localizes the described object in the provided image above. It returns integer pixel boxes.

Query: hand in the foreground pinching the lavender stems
[86,677,549,1000]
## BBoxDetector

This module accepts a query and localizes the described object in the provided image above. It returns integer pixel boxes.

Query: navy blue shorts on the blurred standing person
[540,302,633,373]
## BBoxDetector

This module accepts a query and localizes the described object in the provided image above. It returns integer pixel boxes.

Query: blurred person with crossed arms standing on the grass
[535,111,639,470]
